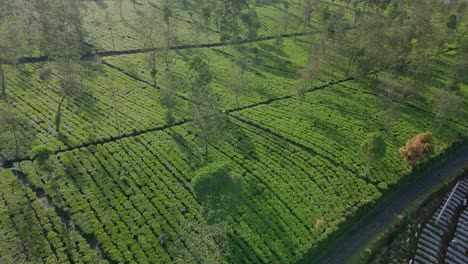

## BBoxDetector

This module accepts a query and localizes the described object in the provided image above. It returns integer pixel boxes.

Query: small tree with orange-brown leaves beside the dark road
[399,132,434,166]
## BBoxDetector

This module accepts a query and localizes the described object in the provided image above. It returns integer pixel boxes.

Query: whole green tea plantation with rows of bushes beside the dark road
[0,0,466,263]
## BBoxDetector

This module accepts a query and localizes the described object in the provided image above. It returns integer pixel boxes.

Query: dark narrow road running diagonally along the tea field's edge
[299,144,468,264]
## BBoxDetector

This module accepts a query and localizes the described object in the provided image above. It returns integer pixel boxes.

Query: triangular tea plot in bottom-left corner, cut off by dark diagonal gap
[0,169,100,263]
